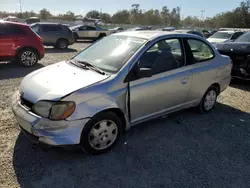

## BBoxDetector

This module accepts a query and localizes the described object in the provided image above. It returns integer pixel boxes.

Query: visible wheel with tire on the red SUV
[16,48,39,67]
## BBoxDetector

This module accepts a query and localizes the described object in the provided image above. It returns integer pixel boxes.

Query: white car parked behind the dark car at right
[207,31,244,45]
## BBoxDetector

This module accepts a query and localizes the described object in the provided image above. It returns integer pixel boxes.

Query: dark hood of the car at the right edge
[216,42,250,53]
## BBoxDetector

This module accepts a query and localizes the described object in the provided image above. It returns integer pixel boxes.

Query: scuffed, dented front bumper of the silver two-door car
[12,92,89,146]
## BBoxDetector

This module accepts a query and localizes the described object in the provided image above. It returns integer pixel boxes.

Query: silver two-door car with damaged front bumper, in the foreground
[12,31,232,154]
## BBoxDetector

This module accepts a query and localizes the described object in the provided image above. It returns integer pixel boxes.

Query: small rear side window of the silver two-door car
[187,39,214,62]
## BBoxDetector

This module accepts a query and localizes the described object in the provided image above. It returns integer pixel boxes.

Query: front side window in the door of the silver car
[138,39,184,74]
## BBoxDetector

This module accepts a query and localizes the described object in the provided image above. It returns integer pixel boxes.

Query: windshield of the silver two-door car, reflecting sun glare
[74,35,146,73]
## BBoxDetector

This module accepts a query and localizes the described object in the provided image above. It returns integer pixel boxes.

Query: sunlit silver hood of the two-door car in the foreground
[20,62,109,103]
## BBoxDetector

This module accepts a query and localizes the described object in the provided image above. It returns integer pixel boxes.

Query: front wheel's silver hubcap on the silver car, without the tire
[89,120,118,150]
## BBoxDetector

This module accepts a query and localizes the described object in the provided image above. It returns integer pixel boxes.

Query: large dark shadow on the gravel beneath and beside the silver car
[13,104,250,188]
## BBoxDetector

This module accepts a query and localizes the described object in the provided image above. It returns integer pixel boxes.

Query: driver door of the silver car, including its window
[129,38,192,124]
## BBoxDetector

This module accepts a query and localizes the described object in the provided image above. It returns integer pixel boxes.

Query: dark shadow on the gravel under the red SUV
[0,62,44,80]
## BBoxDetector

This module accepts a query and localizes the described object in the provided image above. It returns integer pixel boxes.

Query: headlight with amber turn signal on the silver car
[32,101,75,120]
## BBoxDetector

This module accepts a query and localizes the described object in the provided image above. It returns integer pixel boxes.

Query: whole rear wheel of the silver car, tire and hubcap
[199,86,219,113]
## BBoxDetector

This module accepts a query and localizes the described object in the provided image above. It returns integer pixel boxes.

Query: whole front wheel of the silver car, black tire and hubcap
[80,112,122,154]
